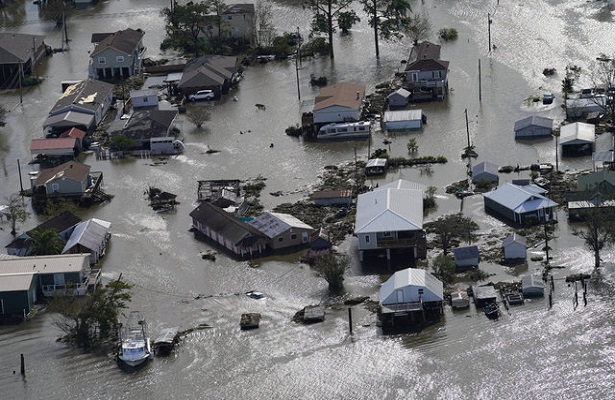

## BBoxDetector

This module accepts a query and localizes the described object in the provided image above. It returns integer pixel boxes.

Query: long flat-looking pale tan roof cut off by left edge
[0,253,90,275]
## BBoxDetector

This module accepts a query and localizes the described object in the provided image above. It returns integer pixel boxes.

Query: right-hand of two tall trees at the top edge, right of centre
[359,0,412,58]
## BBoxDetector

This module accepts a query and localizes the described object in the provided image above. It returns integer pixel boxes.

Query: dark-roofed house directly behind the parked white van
[177,54,237,98]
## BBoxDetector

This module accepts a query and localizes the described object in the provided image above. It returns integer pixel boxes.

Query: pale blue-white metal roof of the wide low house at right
[483,183,557,214]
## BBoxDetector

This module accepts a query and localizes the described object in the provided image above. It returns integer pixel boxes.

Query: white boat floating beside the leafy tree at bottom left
[118,311,153,367]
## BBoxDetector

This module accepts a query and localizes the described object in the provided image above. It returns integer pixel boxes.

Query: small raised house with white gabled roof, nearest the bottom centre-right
[378,268,444,327]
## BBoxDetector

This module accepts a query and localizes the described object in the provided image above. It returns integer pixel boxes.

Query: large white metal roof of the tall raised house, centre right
[355,188,423,233]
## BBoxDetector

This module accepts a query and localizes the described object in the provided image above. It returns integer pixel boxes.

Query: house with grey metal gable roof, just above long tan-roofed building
[62,218,111,265]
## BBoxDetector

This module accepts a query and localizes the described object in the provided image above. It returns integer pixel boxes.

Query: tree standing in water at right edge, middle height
[573,209,615,268]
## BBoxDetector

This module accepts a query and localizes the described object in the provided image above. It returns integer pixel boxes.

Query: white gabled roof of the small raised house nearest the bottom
[380,268,444,304]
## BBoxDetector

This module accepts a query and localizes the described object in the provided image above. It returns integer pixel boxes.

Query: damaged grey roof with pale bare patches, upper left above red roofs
[49,79,113,114]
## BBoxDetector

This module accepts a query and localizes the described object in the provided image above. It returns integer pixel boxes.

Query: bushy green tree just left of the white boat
[50,280,132,349]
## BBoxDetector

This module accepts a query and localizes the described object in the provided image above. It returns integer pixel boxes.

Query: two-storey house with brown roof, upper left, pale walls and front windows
[89,28,145,79]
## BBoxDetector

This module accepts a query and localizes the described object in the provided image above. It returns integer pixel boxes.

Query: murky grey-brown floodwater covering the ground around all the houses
[0,0,615,399]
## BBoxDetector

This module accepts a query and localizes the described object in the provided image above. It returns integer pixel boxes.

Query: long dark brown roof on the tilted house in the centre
[190,202,265,246]
